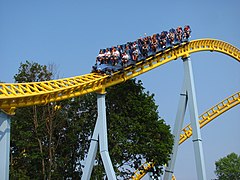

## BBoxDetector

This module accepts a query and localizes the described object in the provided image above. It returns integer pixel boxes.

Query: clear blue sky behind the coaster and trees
[0,0,240,180]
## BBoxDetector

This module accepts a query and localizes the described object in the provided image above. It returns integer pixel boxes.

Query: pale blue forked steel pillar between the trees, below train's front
[82,93,116,180]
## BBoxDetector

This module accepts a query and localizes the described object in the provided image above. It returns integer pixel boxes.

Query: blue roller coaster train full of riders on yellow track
[92,25,191,75]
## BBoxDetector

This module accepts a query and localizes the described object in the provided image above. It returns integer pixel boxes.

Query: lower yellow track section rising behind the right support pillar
[131,91,240,180]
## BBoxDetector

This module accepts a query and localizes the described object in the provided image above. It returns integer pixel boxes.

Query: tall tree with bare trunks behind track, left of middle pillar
[10,61,97,179]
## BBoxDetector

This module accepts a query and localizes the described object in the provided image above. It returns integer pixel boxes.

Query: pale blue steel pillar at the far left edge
[0,111,10,180]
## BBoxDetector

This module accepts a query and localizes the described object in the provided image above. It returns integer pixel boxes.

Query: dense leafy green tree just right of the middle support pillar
[89,79,173,179]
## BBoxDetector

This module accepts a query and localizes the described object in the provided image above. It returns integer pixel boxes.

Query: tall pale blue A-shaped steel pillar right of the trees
[164,57,207,180]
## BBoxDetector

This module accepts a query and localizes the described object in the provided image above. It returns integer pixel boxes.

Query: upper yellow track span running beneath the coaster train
[0,39,240,114]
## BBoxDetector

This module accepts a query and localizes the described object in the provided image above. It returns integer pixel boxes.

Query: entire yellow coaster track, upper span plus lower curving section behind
[0,39,240,179]
